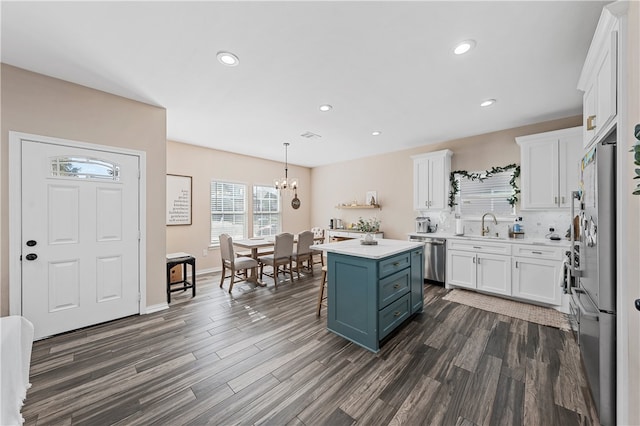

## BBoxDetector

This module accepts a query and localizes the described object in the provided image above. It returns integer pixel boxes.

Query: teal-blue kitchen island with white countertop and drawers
[314,239,424,352]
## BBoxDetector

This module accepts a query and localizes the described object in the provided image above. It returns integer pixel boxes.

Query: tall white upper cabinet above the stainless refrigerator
[578,4,618,148]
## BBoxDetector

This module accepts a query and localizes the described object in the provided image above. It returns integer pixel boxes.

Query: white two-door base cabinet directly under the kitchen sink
[446,240,511,296]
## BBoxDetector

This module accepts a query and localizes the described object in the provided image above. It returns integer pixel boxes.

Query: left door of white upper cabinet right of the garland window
[520,137,558,210]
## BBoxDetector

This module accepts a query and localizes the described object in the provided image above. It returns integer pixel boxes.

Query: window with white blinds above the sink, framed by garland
[456,172,514,217]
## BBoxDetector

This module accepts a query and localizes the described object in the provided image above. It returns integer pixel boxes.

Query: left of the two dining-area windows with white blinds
[211,181,247,246]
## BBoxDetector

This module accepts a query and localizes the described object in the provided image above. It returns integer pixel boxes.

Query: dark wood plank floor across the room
[23,266,598,425]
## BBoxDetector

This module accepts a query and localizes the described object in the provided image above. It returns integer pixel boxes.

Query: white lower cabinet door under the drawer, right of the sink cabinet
[513,257,562,305]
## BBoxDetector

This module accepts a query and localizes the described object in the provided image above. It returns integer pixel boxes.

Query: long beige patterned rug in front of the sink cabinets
[443,288,570,330]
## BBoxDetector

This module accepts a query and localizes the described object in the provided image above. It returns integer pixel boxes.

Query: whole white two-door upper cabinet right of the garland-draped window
[516,127,582,210]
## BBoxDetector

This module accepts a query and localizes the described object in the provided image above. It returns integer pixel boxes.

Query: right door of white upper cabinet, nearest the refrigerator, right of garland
[558,128,582,208]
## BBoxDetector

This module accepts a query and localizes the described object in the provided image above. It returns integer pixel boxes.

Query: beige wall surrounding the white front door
[0,64,167,315]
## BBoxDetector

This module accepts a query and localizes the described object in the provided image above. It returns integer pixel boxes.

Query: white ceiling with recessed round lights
[1,1,608,167]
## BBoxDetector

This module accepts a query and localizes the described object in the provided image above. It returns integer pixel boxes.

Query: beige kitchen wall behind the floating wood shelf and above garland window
[311,116,582,239]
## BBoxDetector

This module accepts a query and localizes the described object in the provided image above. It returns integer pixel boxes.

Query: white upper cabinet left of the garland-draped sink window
[411,149,453,211]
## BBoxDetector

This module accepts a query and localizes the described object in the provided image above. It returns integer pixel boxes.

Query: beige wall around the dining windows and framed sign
[167,141,311,271]
